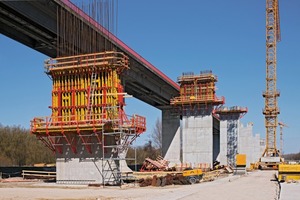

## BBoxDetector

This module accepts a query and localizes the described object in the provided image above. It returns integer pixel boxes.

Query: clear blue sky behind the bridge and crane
[0,0,300,153]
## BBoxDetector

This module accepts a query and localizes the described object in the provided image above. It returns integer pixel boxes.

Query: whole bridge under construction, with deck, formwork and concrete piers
[0,0,262,185]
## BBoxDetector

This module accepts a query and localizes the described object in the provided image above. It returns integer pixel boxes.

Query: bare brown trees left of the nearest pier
[0,124,55,166]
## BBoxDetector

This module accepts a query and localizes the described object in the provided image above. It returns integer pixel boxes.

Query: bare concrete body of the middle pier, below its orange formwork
[162,107,220,167]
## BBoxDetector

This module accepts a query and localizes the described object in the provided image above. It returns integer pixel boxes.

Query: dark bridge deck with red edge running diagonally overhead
[0,0,179,109]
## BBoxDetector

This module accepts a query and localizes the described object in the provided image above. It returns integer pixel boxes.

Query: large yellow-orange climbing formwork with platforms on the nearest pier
[31,51,146,184]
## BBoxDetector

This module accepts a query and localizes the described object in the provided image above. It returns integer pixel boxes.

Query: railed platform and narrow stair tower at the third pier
[214,106,248,167]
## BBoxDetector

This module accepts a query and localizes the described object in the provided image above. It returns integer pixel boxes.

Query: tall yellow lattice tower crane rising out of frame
[260,0,281,167]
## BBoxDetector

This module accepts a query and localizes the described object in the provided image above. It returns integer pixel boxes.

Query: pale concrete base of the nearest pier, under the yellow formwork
[56,136,130,184]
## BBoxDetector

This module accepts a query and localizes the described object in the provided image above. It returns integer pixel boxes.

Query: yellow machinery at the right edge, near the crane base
[278,164,300,182]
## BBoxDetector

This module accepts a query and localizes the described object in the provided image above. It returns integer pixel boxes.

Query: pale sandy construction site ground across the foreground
[0,171,300,200]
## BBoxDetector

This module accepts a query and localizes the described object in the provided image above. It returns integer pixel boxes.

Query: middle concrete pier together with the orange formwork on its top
[165,71,225,167]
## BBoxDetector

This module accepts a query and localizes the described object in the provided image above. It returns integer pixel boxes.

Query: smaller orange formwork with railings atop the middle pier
[170,70,225,113]
